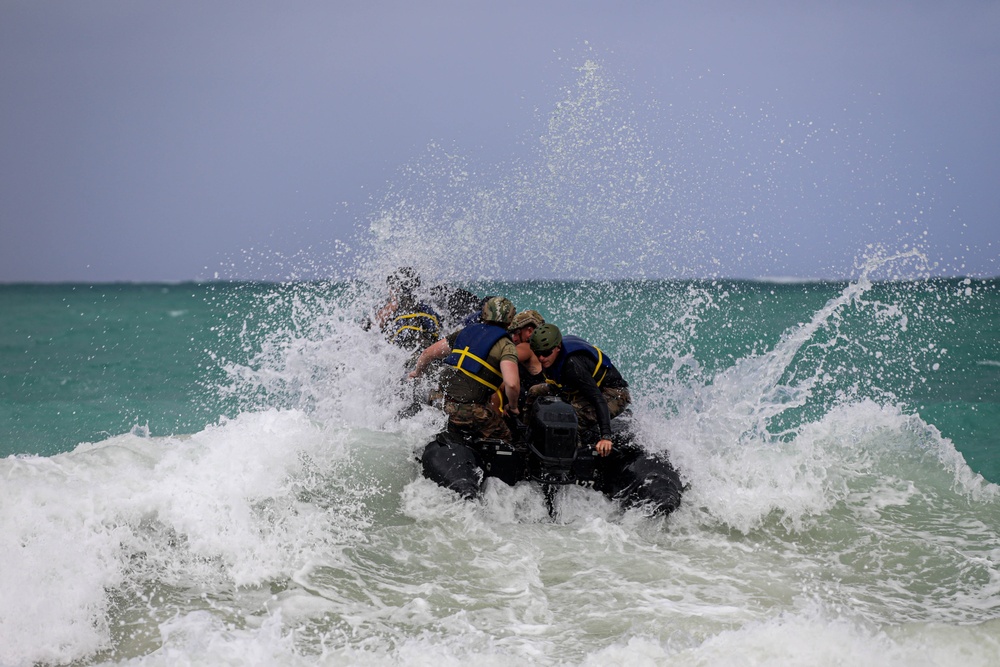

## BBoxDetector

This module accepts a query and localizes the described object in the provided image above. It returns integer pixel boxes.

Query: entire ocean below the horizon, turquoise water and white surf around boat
[0,273,1000,667]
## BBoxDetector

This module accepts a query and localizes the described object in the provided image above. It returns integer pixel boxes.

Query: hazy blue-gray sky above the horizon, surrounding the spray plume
[0,0,1000,282]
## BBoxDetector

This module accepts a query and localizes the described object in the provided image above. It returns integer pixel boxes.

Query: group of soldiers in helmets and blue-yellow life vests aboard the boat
[375,267,631,456]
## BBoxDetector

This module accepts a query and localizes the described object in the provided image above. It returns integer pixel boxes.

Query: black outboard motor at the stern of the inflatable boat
[527,396,579,484]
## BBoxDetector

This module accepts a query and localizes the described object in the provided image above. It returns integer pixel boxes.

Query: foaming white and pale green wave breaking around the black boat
[0,386,1000,664]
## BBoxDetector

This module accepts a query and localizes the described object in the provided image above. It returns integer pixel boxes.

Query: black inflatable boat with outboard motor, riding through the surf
[420,396,683,514]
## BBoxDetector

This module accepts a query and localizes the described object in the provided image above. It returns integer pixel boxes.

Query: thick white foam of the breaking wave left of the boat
[0,410,386,664]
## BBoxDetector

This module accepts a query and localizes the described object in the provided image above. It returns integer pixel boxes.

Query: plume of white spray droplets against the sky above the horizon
[366,60,764,288]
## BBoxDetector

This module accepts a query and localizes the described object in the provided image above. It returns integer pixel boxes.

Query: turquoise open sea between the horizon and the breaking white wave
[0,279,1000,482]
